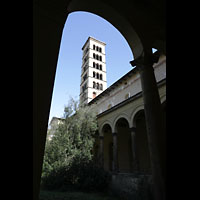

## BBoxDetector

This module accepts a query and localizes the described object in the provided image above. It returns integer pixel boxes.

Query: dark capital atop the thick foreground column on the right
[130,51,160,69]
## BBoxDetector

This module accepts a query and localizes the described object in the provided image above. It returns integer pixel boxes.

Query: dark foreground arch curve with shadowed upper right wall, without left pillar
[67,0,166,55]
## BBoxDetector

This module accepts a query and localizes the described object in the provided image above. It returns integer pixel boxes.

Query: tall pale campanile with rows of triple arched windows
[80,37,107,104]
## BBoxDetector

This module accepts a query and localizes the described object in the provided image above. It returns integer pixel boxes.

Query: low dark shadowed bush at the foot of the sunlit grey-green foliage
[43,157,111,192]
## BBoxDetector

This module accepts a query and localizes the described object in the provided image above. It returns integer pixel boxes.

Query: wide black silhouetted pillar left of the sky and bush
[33,1,67,200]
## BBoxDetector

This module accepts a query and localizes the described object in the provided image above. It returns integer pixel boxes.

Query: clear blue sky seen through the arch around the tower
[49,12,133,122]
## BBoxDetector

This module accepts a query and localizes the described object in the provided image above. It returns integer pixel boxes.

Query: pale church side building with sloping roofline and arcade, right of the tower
[87,53,166,173]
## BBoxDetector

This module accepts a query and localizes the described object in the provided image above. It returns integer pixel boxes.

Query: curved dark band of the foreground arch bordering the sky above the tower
[67,0,143,58]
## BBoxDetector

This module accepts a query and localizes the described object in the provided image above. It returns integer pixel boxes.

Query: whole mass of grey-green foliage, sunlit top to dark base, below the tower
[41,99,110,192]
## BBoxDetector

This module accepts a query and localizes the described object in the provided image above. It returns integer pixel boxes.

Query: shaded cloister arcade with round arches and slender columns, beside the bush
[95,88,166,177]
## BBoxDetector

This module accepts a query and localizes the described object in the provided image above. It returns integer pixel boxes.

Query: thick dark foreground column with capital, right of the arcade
[131,49,165,200]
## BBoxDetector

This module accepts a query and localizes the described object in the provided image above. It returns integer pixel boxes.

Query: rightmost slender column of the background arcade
[130,127,139,172]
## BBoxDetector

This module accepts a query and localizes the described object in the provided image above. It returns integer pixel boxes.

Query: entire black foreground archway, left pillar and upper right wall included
[33,0,165,199]
